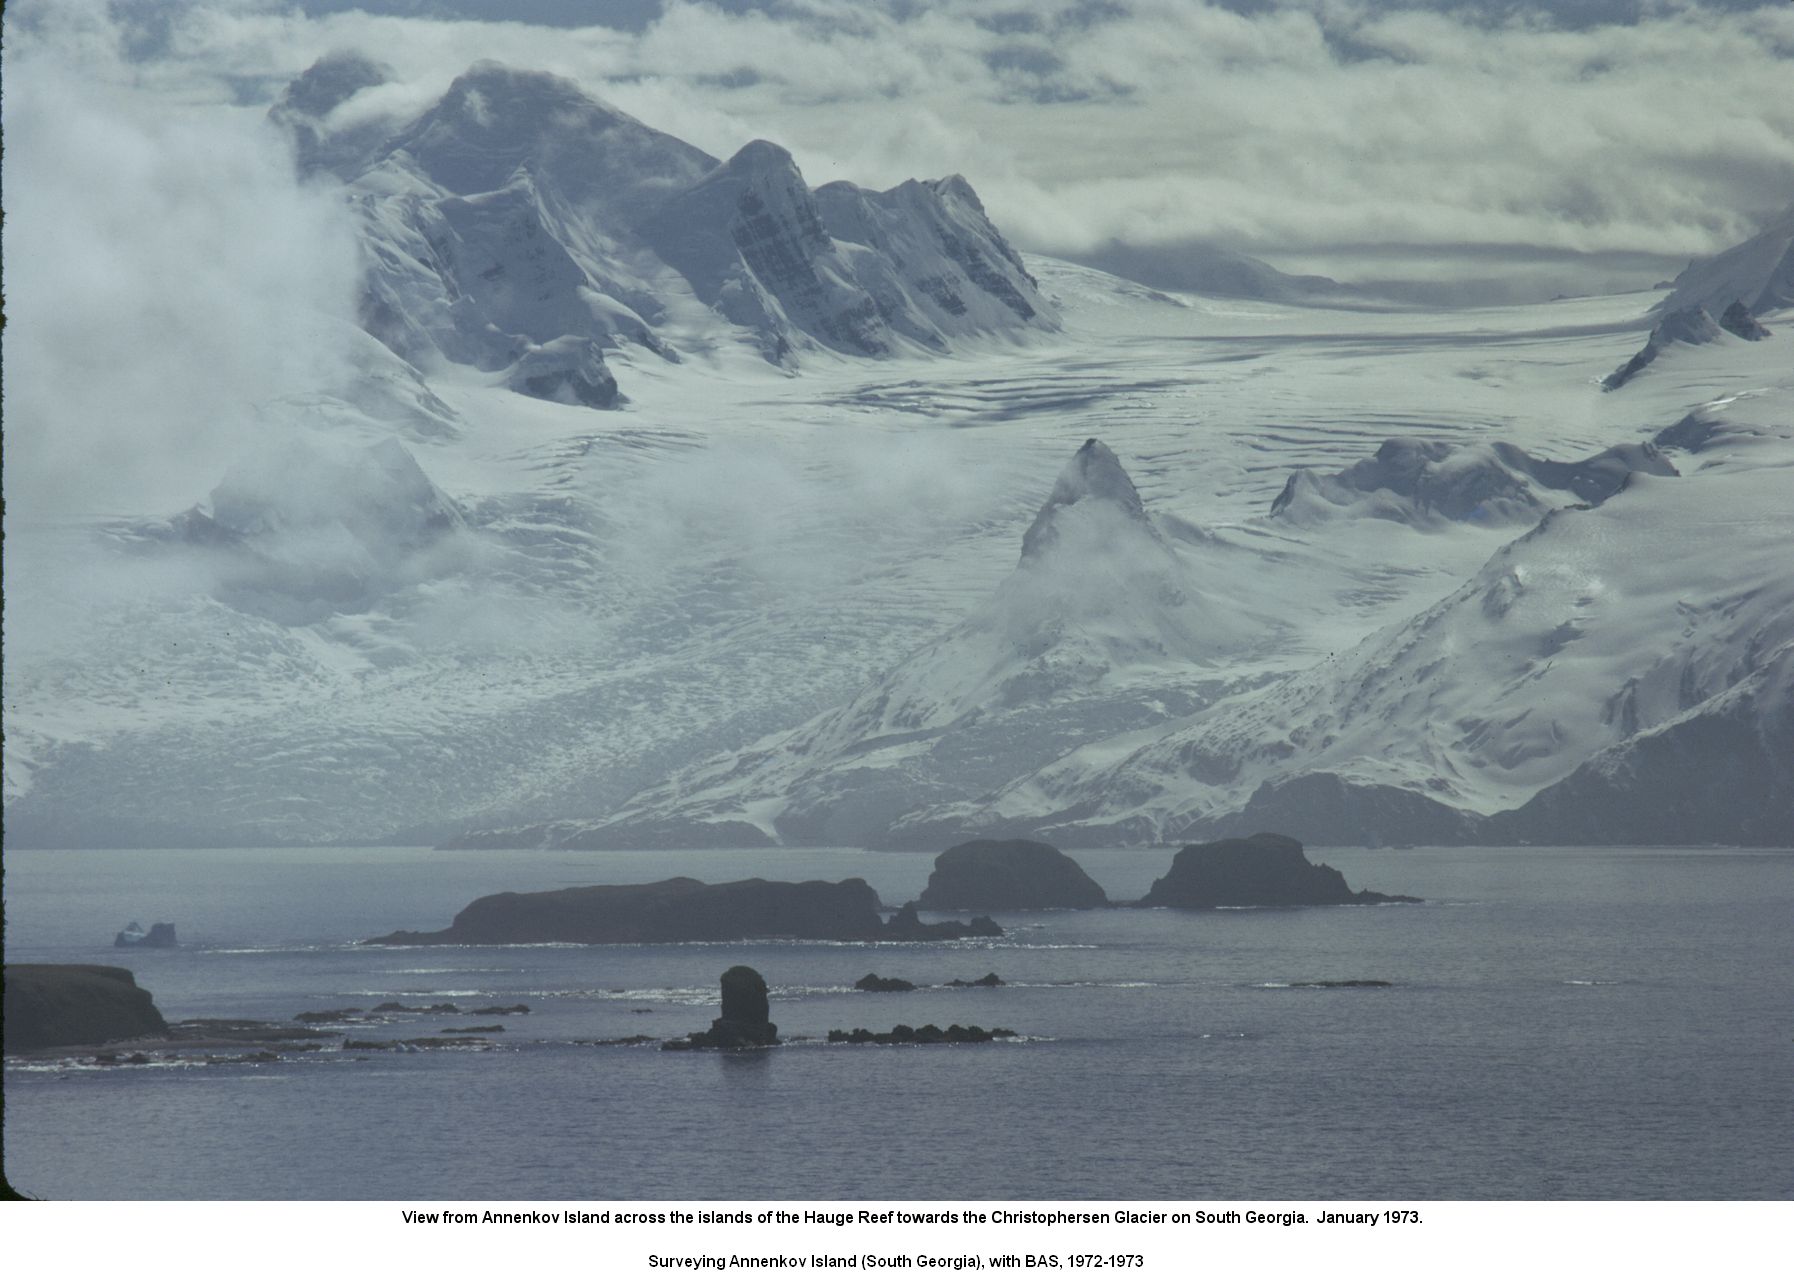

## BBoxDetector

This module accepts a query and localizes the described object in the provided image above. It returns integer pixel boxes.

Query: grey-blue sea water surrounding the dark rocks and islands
[5,848,1794,1201]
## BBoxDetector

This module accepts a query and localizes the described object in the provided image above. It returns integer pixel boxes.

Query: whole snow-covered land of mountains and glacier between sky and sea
[5,56,1794,848]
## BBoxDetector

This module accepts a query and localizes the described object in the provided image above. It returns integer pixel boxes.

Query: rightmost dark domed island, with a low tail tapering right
[1139,832,1419,911]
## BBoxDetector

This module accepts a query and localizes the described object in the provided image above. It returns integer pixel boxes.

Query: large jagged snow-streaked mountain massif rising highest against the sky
[273,56,1057,394]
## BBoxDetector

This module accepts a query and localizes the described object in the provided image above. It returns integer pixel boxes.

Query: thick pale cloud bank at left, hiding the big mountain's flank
[5,7,357,527]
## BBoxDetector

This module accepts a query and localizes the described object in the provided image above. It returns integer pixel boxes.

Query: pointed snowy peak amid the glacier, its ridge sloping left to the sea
[459,437,1281,846]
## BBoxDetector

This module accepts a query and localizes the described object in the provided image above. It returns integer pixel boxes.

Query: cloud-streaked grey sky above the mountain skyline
[7,0,1794,296]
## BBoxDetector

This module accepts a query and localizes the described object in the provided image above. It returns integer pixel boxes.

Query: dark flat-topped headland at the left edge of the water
[5,963,169,1052]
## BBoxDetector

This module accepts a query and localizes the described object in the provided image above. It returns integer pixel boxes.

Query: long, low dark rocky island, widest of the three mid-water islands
[364,877,1003,947]
